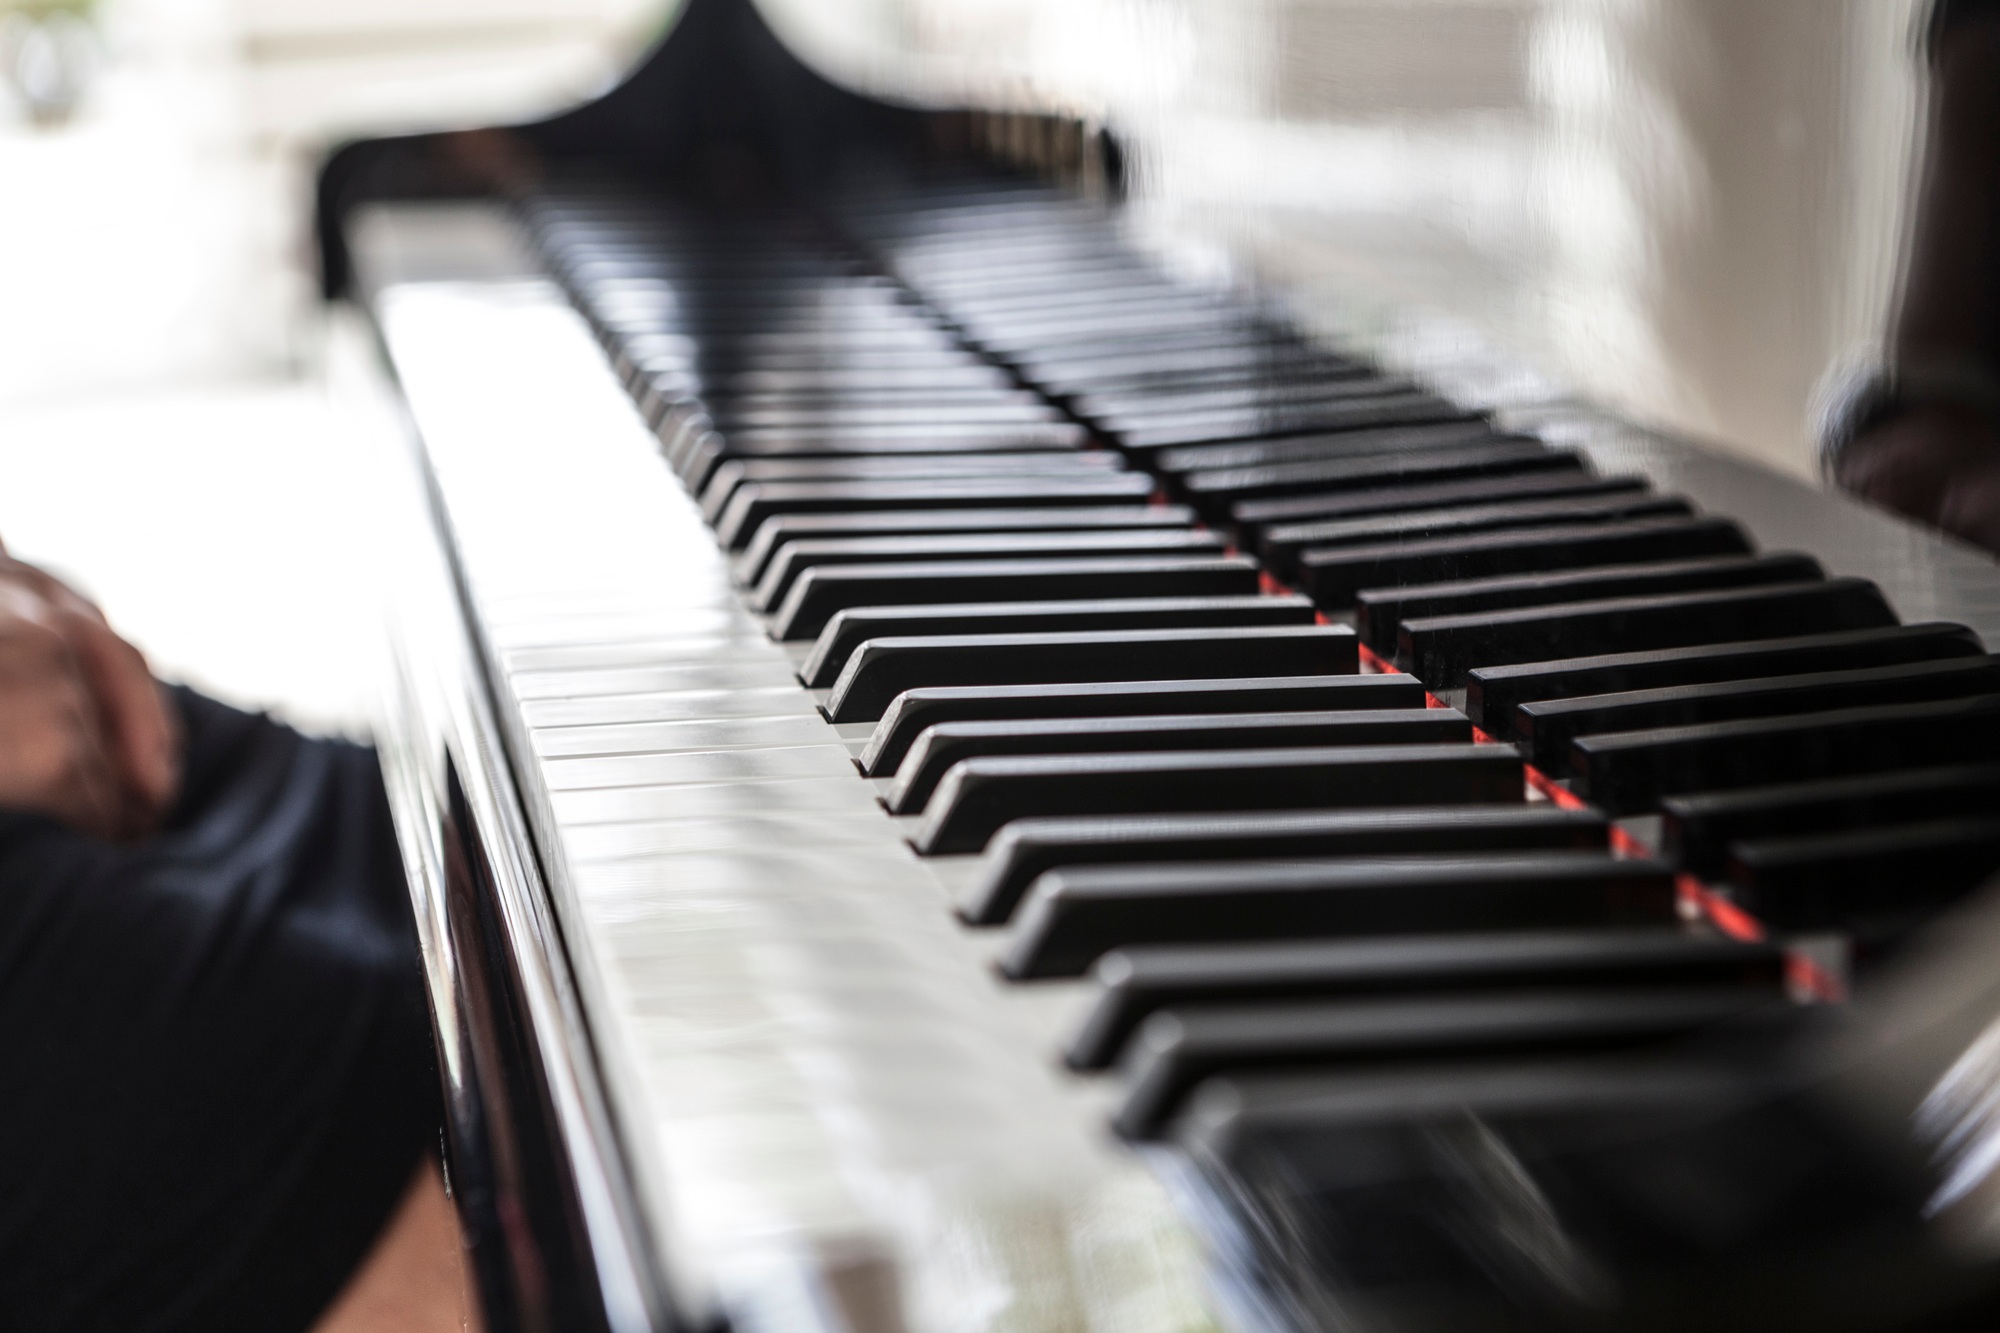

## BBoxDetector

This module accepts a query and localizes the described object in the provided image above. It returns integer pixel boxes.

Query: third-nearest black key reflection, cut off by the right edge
[1570,697,2000,815]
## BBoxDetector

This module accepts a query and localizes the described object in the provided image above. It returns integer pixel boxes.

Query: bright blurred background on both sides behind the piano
[0,0,1922,731]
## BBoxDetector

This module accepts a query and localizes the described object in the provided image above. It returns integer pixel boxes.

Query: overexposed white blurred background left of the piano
[0,0,666,733]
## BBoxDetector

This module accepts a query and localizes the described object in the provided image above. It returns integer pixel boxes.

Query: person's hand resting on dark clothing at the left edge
[0,552,180,839]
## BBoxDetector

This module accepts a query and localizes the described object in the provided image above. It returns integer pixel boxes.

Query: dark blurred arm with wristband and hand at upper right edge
[1830,0,2000,552]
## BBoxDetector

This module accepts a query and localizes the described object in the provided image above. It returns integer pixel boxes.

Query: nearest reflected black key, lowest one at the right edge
[1728,813,2000,935]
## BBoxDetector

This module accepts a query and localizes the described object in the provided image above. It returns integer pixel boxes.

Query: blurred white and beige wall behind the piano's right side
[774,0,1920,472]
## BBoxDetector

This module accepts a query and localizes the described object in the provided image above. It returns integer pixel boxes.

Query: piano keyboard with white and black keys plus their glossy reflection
[364,178,2000,1329]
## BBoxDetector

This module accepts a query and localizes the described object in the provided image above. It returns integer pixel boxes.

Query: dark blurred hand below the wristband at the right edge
[1834,406,2000,554]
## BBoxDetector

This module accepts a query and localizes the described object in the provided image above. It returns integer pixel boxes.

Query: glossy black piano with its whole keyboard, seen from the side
[318,0,2000,1333]
